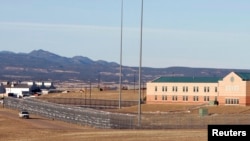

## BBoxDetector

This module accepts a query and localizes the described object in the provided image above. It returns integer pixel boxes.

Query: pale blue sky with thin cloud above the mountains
[0,0,250,69]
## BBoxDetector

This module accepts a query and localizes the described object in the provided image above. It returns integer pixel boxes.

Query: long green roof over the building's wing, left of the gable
[152,77,222,83]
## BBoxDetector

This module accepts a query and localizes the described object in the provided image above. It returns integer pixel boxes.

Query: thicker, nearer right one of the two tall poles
[138,0,143,126]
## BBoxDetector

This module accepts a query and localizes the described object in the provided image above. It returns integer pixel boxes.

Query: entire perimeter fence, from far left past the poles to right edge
[4,98,250,129]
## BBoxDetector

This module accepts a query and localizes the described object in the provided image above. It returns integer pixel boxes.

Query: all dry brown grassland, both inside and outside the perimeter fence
[0,90,250,141]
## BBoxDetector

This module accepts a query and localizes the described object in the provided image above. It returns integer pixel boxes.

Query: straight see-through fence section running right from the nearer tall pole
[140,113,250,129]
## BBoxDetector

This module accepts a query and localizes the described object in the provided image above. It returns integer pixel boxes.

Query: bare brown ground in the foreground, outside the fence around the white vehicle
[0,105,207,141]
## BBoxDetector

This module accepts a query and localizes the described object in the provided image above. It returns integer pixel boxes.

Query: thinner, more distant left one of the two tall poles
[119,0,123,109]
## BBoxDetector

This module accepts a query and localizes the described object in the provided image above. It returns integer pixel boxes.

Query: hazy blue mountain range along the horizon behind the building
[0,50,250,83]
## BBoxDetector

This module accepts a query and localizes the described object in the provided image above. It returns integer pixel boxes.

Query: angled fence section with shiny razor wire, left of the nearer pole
[3,97,136,129]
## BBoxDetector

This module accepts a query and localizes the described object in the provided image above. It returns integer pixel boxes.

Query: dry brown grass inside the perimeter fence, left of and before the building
[39,90,250,114]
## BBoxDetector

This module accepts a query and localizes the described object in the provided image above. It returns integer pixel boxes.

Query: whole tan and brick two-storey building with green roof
[147,72,250,105]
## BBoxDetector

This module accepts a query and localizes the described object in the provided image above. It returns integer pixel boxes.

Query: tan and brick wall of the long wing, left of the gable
[147,83,218,104]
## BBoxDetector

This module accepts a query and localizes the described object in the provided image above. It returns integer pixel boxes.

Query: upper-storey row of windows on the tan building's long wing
[155,86,218,93]
